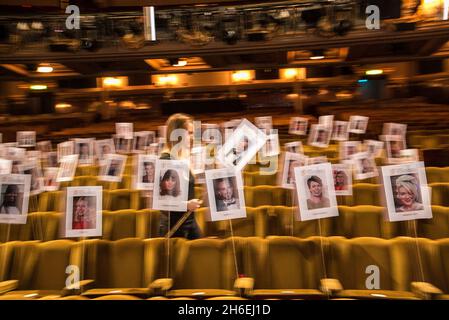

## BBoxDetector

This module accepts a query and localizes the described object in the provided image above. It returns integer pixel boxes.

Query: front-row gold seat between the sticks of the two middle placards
[243,237,325,299]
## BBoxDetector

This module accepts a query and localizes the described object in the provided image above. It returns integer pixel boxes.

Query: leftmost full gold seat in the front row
[0,240,79,298]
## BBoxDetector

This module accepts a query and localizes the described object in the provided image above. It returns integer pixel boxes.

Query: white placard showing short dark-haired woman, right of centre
[295,163,338,221]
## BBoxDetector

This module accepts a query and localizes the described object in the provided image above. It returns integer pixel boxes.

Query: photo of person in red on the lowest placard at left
[72,196,96,230]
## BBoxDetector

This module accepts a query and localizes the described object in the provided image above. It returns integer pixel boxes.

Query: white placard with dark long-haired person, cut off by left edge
[0,174,31,224]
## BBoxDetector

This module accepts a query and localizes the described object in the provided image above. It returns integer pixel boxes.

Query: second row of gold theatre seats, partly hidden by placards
[0,206,449,242]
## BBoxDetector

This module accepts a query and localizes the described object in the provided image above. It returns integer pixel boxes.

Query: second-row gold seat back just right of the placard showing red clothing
[103,209,137,240]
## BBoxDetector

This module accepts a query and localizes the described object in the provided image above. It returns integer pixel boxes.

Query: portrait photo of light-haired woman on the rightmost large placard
[392,174,424,212]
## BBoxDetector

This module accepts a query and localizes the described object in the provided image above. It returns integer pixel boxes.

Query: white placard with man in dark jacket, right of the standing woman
[206,168,246,221]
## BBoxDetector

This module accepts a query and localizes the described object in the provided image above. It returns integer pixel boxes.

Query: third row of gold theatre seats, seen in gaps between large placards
[29,182,449,212]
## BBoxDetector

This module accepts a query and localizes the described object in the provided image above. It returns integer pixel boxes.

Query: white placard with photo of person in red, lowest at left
[65,186,103,238]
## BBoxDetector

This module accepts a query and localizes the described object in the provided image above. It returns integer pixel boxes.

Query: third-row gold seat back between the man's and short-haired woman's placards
[244,186,294,207]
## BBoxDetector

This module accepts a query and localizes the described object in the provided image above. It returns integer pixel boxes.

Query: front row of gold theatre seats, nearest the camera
[0,237,449,299]
